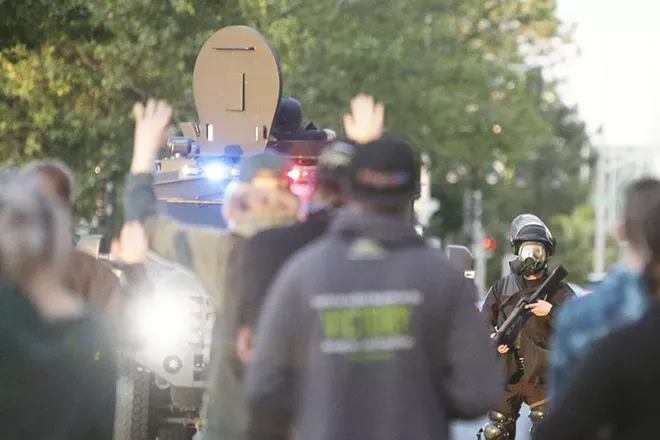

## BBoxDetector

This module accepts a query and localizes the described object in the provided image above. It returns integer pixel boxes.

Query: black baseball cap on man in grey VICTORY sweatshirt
[346,133,419,207]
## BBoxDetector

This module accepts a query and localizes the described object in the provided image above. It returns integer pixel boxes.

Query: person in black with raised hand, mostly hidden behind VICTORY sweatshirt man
[202,95,390,440]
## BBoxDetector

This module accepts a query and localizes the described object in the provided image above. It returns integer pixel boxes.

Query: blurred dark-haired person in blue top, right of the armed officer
[550,178,660,396]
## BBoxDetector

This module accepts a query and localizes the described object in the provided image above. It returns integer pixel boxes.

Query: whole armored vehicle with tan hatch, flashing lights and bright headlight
[78,26,327,440]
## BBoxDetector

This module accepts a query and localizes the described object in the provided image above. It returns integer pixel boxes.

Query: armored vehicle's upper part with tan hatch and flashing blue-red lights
[154,26,328,227]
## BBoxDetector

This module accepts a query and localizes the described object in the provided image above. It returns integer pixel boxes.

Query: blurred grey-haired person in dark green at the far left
[0,173,116,440]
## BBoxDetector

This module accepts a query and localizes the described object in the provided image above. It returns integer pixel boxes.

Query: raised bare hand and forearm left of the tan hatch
[131,99,172,173]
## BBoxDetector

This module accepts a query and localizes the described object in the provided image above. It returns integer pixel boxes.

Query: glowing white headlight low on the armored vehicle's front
[133,293,195,347]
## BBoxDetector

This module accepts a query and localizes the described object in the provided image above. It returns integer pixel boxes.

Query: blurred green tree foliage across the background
[0,0,581,242]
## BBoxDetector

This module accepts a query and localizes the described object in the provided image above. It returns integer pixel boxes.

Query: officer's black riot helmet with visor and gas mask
[509,214,556,276]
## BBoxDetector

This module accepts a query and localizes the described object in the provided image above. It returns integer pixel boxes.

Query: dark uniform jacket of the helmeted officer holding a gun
[482,274,575,384]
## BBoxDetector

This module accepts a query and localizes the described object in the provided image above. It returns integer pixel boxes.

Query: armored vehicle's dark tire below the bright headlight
[114,353,153,440]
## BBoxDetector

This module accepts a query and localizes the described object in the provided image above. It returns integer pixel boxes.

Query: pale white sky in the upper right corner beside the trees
[556,0,660,146]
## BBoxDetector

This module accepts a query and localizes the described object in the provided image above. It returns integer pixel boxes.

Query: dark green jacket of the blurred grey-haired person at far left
[0,281,117,440]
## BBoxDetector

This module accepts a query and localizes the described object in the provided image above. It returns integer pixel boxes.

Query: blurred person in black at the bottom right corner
[537,191,660,440]
